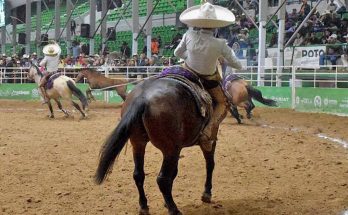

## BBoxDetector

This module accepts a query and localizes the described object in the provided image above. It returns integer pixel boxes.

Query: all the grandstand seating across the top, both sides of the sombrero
[0,0,347,56]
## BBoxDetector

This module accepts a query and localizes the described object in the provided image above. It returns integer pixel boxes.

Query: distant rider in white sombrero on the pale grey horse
[39,41,61,104]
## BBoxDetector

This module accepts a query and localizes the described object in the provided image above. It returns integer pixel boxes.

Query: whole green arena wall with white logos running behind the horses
[0,84,348,115]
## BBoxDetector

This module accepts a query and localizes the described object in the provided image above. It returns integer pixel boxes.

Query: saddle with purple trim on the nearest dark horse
[158,66,213,119]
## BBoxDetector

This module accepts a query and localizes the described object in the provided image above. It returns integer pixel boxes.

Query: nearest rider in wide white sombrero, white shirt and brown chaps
[174,2,242,151]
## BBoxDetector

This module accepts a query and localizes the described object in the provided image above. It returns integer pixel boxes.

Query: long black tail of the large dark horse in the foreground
[95,99,145,184]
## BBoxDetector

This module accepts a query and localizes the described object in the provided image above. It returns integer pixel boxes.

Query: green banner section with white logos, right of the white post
[295,88,348,114]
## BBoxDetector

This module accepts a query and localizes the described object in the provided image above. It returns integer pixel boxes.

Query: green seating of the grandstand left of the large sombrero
[1,0,204,56]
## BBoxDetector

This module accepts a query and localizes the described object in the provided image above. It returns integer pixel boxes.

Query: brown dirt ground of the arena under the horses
[0,100,348,215]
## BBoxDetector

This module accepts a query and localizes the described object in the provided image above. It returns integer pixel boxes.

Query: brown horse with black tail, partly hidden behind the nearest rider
[223,74,277,124]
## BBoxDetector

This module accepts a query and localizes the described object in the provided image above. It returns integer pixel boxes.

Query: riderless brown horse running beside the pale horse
[75,69,128,101]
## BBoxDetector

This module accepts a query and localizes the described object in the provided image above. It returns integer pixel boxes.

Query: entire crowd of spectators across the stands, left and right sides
[0,0,348,76]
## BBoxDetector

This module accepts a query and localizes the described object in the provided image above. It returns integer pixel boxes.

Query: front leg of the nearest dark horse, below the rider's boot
[201,141,216,203]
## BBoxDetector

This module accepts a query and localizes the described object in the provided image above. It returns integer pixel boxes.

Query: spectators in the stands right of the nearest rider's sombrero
[217,0,348,64]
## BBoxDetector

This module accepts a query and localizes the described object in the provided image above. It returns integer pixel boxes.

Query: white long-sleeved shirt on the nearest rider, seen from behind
[174,29,242,75]
